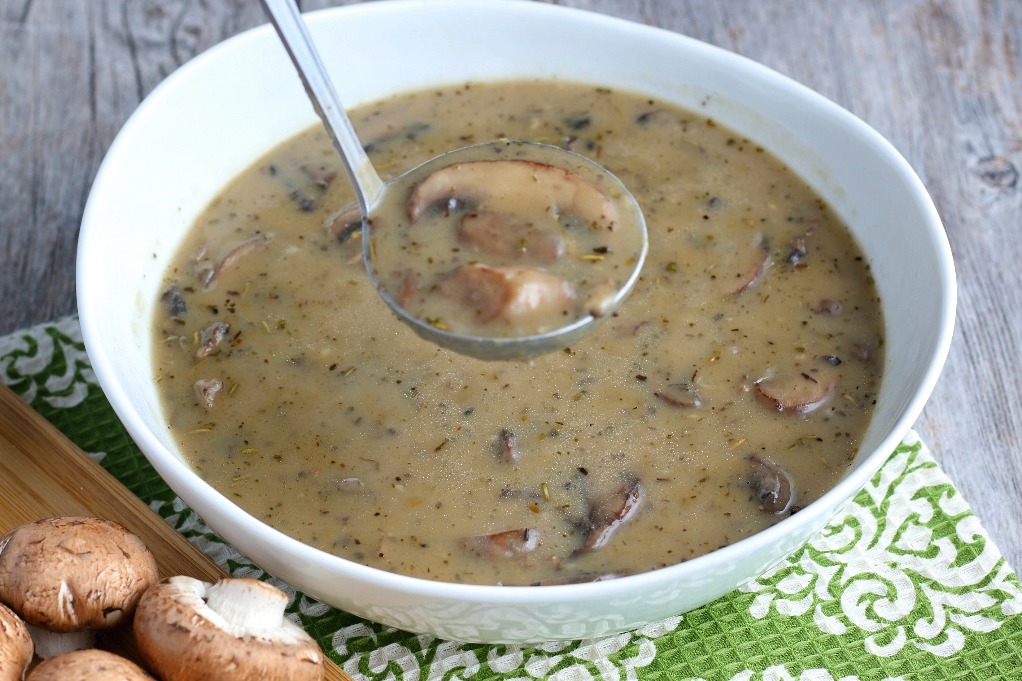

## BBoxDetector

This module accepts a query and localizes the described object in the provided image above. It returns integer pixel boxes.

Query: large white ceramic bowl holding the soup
[78,0,956,642]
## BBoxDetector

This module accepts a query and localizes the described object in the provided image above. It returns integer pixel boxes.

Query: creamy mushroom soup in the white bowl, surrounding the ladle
[153,82,883,585]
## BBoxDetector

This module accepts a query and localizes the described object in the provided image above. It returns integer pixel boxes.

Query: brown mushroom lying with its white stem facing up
[134,577,324,681]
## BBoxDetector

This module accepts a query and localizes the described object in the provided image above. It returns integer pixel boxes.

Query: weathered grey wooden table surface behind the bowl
[0,0,1022,569]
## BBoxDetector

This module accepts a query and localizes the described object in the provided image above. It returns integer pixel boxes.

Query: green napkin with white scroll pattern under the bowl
[0,318,1022,681]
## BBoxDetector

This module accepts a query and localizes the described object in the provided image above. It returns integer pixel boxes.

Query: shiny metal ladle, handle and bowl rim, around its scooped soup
[262,0,648,360]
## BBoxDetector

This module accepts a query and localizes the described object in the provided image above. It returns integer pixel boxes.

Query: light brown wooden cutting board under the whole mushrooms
[0,385,352,681]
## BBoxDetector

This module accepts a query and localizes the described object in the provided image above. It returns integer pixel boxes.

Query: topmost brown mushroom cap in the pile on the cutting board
[0,517,158,632]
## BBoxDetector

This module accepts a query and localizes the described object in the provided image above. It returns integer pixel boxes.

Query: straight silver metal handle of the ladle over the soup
[261,0,383,217]
